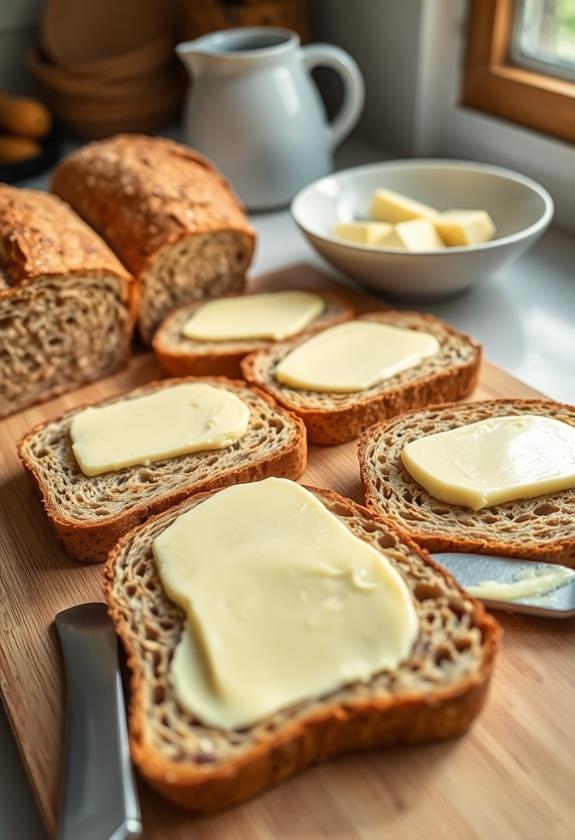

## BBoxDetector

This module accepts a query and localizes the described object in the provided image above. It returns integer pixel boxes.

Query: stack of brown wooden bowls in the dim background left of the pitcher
[30,0,185,139]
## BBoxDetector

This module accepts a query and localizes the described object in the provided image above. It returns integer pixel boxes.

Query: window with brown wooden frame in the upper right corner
[462,0,575,142]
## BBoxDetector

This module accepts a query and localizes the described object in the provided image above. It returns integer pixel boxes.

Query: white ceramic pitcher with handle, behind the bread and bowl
[176,26,364,210]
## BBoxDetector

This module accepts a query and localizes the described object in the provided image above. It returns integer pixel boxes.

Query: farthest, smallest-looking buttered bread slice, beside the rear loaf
[152,289,354,376]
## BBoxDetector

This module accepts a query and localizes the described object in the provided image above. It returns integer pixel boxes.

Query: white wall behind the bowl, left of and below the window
[311,0,575,230]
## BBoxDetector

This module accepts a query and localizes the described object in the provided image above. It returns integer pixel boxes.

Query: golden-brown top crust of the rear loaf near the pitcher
[51,134,255,277]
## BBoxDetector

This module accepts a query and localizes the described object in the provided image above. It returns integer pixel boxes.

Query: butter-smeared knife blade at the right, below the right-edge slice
[431,552,575,618]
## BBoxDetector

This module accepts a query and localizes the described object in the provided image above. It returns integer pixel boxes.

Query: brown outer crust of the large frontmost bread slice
[104,487,501,812]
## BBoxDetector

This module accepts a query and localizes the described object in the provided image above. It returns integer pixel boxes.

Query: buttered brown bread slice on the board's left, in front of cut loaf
[18,378,306,563]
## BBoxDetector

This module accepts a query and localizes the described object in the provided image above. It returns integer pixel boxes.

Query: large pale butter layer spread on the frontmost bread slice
[153,478,418,730]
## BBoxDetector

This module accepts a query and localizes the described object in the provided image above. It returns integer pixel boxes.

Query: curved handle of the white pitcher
[301,44,365,149]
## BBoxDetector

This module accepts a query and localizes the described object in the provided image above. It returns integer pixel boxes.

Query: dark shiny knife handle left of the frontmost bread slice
[55,604,142,840]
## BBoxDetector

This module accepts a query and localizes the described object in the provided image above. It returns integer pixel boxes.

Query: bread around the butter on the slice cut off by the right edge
[359,400,575,567]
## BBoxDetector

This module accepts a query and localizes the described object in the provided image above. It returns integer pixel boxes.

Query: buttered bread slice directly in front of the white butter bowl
[242,310,481,444]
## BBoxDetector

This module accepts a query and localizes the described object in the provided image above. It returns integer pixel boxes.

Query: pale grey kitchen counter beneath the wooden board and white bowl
[0,147,575,840]
